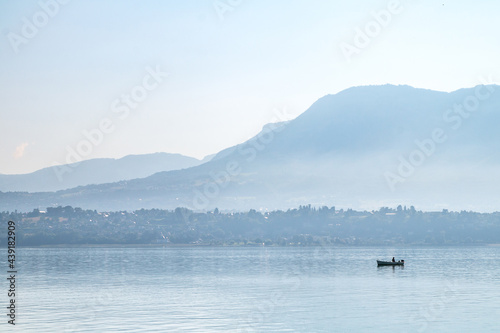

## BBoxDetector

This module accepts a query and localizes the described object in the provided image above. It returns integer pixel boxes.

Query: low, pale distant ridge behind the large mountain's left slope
[0,153,202,192]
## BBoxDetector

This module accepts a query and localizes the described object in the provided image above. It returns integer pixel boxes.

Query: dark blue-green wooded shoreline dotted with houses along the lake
[0,205,500,246]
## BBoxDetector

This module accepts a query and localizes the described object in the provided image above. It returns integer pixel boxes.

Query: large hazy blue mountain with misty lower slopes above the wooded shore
[0,85,500,211]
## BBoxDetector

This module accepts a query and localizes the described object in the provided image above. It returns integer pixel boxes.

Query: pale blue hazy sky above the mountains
[0,0,500,174]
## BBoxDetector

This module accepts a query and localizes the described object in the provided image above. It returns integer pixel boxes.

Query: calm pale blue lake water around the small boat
[6,247,500,332]
